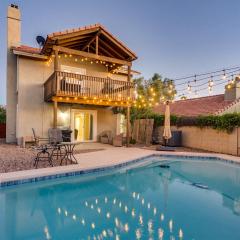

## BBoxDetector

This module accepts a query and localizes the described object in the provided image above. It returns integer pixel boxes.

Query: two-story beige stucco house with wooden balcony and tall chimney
[6,5,137,142]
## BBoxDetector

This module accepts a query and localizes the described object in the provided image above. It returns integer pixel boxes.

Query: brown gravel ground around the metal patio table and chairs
[0,142,103,173]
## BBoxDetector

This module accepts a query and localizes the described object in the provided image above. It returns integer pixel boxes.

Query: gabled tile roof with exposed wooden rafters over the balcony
[41,24,137,62]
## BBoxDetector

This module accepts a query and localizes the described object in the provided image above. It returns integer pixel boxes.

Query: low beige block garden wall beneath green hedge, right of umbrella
[159,126,240,155]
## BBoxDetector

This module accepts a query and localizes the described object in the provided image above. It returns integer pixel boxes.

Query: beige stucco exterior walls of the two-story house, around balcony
[16,57,123,143]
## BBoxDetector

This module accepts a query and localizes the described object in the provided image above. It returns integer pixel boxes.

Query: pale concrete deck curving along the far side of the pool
[0,147,240,184]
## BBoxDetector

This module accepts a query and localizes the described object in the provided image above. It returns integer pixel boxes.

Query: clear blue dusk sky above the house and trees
[0,0,240,104]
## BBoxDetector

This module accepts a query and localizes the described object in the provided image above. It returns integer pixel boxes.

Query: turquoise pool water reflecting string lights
[0,158,240,240]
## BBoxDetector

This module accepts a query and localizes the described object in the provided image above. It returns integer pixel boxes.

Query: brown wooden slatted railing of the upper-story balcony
[44,71,134,102]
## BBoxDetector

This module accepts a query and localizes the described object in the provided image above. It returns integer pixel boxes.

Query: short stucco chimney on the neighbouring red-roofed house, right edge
[224,77,240,101]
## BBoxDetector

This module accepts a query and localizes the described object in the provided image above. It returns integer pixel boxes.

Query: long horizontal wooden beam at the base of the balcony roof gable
[53,45,132,66]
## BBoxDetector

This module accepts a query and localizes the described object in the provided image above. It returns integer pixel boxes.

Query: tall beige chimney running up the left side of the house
[6,4,21,143]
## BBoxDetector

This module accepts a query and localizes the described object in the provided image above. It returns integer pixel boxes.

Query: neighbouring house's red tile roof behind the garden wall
[154,94,236,117]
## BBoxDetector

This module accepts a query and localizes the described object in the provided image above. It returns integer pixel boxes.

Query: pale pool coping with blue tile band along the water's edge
[0,150,240,189]
